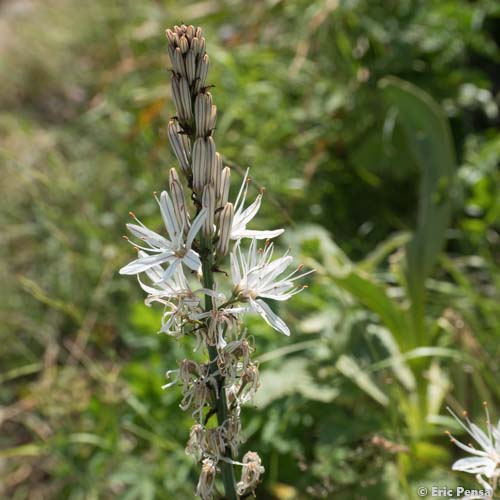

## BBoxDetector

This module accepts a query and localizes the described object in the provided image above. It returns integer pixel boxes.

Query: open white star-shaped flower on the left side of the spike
[120,191,206,282]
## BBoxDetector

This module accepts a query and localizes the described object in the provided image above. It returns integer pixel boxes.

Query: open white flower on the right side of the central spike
[231,238,312,335]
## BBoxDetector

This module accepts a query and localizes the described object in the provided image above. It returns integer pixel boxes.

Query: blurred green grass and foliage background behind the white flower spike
[0,0,500,500]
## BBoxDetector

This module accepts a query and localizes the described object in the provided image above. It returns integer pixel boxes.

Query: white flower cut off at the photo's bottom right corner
[448,405,500,478]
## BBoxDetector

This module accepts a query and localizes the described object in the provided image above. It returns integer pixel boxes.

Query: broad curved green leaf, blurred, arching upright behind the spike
[379,77,456,340]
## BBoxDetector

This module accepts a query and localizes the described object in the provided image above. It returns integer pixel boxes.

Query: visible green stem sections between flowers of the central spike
[201,238,238,500]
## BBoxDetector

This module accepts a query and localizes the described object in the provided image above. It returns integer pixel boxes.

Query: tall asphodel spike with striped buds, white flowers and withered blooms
[120,25,307,499]
